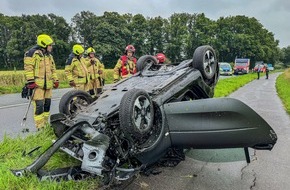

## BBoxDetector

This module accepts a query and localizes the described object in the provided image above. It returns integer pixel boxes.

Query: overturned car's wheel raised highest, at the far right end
[192,45,218,79]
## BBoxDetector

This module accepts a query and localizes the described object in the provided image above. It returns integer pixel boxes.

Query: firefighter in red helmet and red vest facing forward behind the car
[114,45,137,82]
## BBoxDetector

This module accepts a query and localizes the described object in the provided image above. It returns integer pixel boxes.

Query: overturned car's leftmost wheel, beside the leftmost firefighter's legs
[59,90,93,116]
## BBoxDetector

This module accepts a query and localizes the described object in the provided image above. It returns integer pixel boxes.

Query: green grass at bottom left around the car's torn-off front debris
[0,127,98,190]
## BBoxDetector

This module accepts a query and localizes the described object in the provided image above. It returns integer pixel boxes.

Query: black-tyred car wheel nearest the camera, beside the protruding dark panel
[119,89,154,138]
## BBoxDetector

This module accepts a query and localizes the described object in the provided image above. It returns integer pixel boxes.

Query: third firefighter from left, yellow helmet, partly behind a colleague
[86,47,105,97]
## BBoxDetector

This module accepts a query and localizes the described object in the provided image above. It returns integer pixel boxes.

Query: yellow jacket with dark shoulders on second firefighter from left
[64,54,90,84]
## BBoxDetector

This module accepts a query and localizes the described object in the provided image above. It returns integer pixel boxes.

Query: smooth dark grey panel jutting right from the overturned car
[164,98,277,150]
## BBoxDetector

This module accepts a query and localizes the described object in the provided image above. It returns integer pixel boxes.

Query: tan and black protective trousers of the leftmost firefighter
[32,88,52,129]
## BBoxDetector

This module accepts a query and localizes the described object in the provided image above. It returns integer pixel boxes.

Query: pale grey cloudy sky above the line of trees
[0,0,290,48]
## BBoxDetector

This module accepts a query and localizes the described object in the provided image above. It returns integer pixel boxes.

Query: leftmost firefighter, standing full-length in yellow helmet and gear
[24,34,59,129]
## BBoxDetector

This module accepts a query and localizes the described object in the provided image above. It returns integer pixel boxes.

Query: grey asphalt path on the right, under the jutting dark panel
[126,73,290,190]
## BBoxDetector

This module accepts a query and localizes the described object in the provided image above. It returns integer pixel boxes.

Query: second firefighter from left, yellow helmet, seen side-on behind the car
[64,44,90,92]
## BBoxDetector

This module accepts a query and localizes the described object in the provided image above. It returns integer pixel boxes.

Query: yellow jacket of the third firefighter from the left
[85,57,105,80]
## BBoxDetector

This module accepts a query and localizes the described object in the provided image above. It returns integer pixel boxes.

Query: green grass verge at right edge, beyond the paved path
[276,69,290,114]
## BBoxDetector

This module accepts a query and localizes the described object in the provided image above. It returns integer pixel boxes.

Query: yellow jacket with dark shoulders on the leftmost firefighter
[24,46,58,89]
